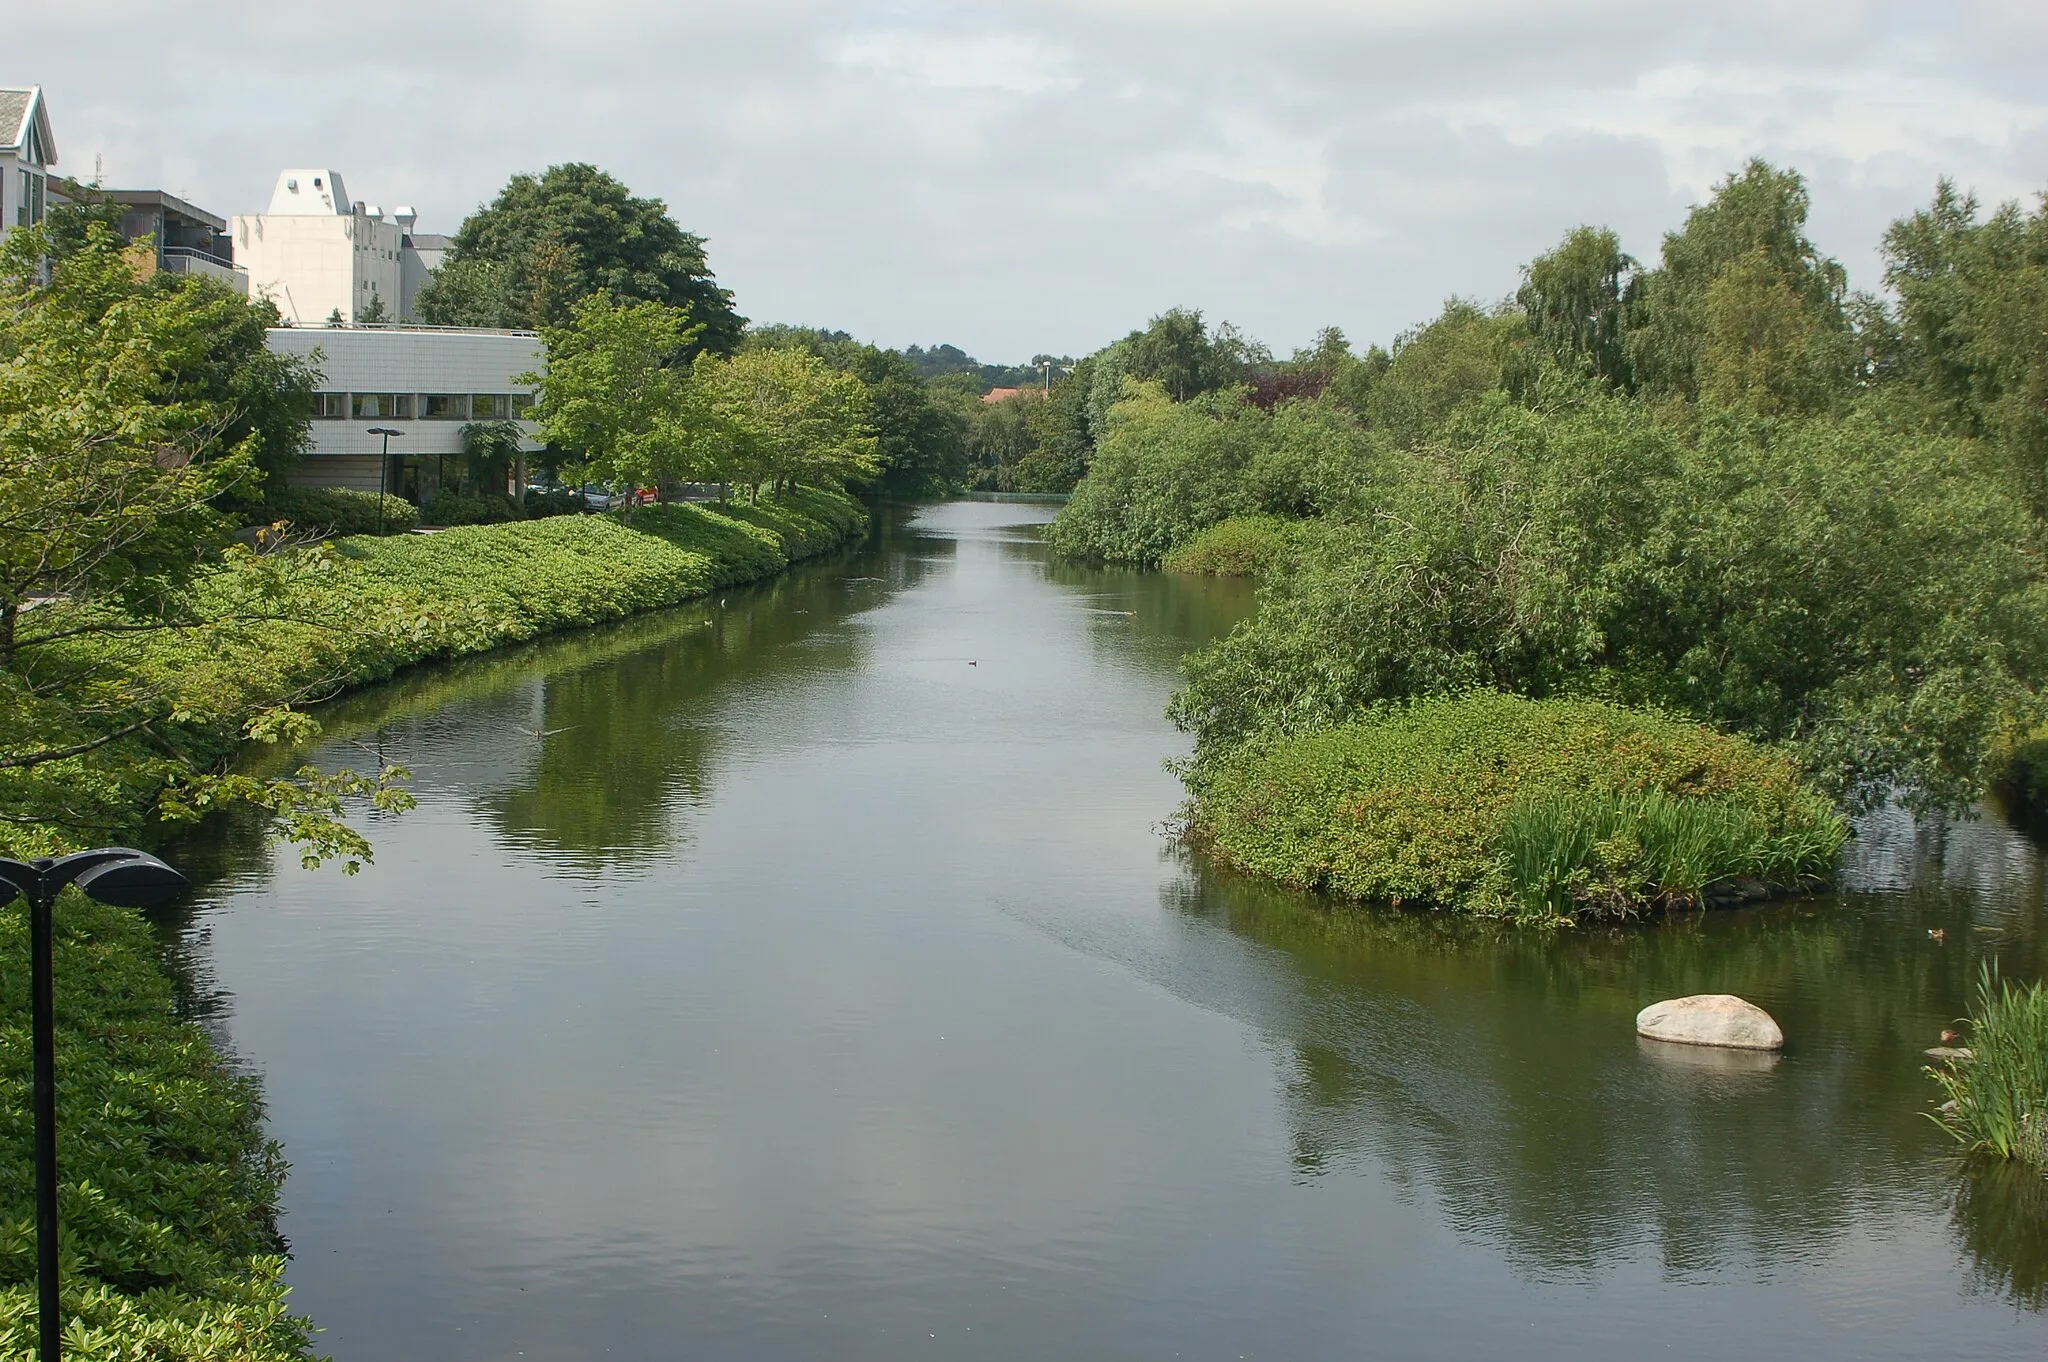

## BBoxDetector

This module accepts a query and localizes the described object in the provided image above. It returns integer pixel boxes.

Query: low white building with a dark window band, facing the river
[270,326,547,502]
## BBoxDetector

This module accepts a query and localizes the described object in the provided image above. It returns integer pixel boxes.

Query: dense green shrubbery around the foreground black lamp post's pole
[0,893,309,1362]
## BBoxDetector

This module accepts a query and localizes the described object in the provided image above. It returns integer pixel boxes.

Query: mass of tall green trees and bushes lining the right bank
[1049,162,2048,905]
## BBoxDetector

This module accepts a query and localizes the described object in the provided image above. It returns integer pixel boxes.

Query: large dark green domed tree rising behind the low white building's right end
[420,164,745,354]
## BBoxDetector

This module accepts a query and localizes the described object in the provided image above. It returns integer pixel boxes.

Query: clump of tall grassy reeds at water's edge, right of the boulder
[1929,965,2048,1172]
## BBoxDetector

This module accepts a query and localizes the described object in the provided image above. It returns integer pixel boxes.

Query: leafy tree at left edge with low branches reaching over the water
[0,221,403,860]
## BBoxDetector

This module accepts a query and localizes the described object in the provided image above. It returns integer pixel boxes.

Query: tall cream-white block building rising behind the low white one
[227,168,446,326]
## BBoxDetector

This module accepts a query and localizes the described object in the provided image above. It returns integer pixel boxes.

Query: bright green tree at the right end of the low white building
[520,291,711,485]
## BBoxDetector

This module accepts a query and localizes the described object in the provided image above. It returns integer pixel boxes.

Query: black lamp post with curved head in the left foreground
[0,846,186,1362]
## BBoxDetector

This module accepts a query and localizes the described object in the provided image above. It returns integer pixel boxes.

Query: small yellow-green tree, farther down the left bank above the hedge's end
[696,350,881,490]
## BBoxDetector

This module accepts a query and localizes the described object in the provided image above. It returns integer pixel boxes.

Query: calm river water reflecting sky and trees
[172,504,2048,1362]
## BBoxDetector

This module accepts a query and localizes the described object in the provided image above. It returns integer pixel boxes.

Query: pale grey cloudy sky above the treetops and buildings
[19,0,2048,360]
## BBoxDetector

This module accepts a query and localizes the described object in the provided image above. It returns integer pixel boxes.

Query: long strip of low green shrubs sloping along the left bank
[0,490,866,854]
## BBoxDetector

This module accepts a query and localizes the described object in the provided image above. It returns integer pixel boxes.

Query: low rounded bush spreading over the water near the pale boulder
[1188,692,1847,916]
